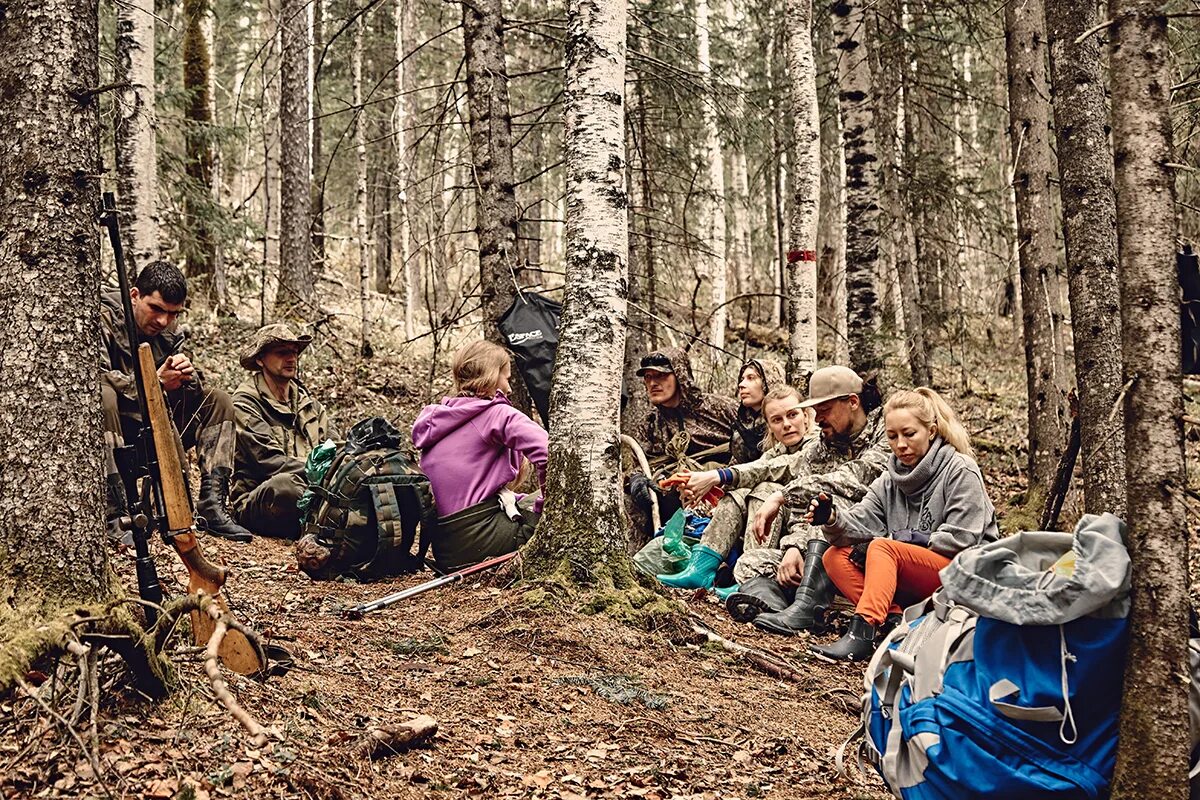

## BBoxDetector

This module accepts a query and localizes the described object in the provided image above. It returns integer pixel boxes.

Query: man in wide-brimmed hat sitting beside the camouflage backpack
[233,323,335,539]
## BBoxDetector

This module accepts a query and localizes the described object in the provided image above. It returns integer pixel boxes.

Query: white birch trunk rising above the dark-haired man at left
[113,4,160,275]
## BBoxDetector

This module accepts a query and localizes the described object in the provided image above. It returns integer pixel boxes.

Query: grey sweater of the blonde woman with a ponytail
[824,437,1000,558]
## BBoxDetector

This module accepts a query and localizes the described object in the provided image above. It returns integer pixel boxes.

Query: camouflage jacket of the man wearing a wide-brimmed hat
[230,372,336,499]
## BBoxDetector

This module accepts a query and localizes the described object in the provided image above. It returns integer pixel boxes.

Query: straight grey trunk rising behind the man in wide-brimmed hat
[275,0,314,317]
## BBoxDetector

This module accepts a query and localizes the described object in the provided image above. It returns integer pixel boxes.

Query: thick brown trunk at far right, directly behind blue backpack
[1109,0,1190,800]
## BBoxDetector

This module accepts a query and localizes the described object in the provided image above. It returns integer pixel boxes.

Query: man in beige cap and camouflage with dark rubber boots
[725,366,890,636]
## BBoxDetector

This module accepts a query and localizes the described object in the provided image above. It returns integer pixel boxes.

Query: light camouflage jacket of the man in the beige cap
[780,409,892,548]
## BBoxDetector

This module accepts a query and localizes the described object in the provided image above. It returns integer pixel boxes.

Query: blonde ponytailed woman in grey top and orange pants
[806,387,1000,661]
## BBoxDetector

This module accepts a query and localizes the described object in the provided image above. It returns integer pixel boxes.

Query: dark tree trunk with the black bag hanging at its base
[463,0,521,344]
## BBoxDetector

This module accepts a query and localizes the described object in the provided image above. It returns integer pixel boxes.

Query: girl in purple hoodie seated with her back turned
[413,341,547,571]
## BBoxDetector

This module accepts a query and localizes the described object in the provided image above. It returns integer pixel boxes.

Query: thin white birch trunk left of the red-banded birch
[696,0,728,359]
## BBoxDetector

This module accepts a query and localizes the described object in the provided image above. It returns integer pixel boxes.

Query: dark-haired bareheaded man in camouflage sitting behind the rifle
[100,261,250,542]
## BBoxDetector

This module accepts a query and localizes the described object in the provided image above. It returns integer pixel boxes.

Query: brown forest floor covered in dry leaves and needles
[0,297,1185,800]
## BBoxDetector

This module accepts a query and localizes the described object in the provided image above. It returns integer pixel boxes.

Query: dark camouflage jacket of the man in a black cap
[635,348,738,471]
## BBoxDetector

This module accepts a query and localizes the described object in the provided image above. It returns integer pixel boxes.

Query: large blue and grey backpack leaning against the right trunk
[859,515,1129,800]
